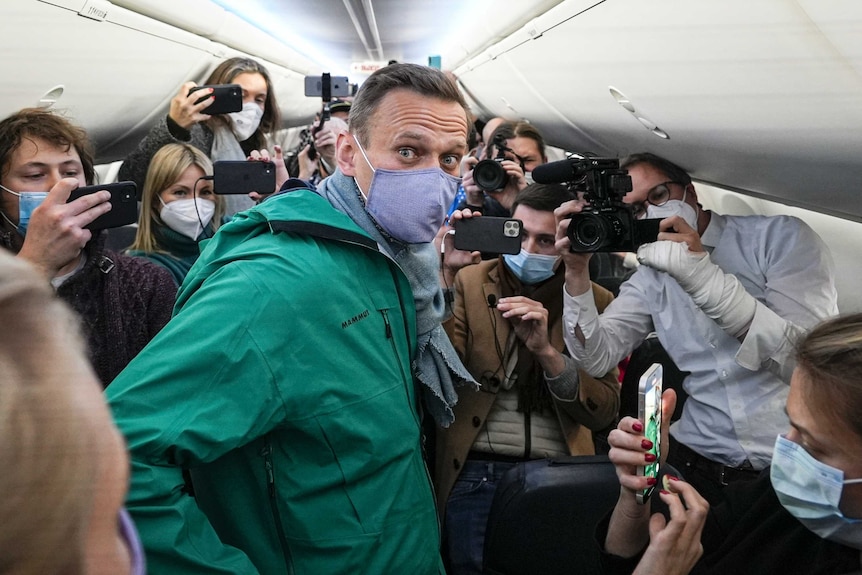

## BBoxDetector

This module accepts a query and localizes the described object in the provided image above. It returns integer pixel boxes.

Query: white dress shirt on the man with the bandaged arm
[563,213,838,469]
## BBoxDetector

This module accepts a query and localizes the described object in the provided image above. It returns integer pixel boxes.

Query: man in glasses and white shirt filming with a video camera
[557,153,838,504]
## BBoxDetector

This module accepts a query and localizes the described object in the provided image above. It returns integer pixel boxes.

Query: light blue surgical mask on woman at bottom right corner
[770,435,862,549]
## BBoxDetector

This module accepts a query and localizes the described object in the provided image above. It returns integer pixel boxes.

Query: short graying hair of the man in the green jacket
[350,64,471,146]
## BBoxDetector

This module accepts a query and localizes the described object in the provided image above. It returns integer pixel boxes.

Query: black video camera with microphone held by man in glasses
[533,158,661,252]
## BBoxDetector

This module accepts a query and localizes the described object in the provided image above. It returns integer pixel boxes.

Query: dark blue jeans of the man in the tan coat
[444,460,515,575]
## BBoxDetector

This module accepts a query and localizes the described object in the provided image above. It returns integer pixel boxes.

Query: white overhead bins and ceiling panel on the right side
[455,0,862,220]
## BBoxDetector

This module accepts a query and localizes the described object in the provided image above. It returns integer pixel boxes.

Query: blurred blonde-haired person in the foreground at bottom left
[0,252,145,575]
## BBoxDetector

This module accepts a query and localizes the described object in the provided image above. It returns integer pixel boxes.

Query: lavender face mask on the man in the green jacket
[353,136,461,244]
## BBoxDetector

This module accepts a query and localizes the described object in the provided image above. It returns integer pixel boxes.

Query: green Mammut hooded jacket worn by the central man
[107,190,444,575]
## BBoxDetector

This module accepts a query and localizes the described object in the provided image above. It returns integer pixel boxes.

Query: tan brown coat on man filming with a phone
[435,259,620,510]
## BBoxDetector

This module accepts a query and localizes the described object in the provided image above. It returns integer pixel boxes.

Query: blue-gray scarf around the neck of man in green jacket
[317,170,478,427]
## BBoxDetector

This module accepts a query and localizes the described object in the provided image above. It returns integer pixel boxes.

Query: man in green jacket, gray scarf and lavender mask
[108,64,470,575]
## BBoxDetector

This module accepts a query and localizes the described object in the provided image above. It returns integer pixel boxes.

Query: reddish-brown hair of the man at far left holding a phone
[0,108,96,186]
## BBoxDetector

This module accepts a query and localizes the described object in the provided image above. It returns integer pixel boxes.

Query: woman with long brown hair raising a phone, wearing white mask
[120,57,283,215]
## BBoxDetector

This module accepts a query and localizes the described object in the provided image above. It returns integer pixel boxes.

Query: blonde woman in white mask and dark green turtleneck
[127,144,225,285]
